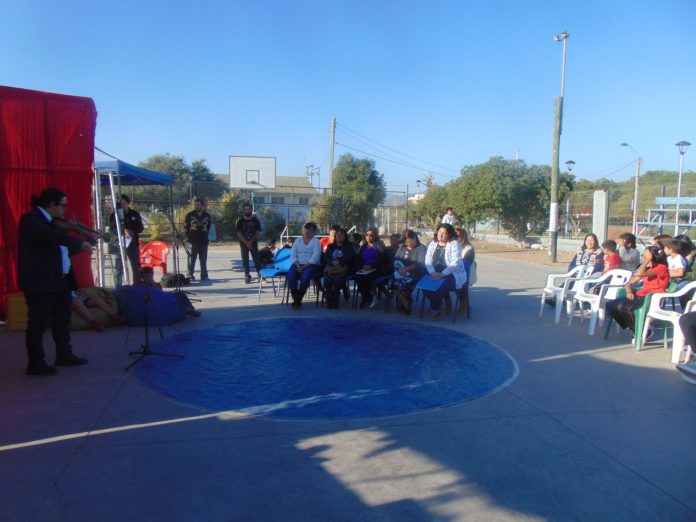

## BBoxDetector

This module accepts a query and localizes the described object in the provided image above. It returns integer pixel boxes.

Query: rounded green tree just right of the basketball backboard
[330,154,387,230]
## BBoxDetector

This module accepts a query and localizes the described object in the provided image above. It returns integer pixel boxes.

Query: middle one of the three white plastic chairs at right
[567,268,633,335]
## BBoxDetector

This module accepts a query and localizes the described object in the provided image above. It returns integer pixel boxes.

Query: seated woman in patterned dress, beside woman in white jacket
[392,230,426,315]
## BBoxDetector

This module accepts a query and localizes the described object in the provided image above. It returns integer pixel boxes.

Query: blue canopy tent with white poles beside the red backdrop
[94,147,179,286]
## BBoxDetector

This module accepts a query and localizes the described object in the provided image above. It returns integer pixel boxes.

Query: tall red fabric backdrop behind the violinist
[0,86,97,318]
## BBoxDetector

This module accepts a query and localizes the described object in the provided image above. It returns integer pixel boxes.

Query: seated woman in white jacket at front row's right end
[423,223,466,321]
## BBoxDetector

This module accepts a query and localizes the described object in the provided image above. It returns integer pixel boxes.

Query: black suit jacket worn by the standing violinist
[17,208,82,293]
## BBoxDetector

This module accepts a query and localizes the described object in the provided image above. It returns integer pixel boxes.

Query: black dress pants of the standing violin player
[24,280,72,366]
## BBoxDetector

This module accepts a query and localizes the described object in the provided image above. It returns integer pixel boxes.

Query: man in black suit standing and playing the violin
[18,188,92,375]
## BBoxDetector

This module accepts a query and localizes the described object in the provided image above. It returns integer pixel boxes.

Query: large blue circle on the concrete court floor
[136,318,517,419]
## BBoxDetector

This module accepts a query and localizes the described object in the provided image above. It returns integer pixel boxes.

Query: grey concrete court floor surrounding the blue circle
[0,247,696,522]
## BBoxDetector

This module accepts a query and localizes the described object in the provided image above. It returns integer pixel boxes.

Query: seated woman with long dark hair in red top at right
[607,245,669,332]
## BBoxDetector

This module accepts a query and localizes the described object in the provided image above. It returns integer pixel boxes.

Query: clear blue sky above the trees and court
[0,0,696,192]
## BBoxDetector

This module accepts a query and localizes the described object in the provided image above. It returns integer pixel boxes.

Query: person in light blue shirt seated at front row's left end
[287,222,321,309]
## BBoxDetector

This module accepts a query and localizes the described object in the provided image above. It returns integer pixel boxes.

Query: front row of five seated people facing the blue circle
[288,223,476,319]
